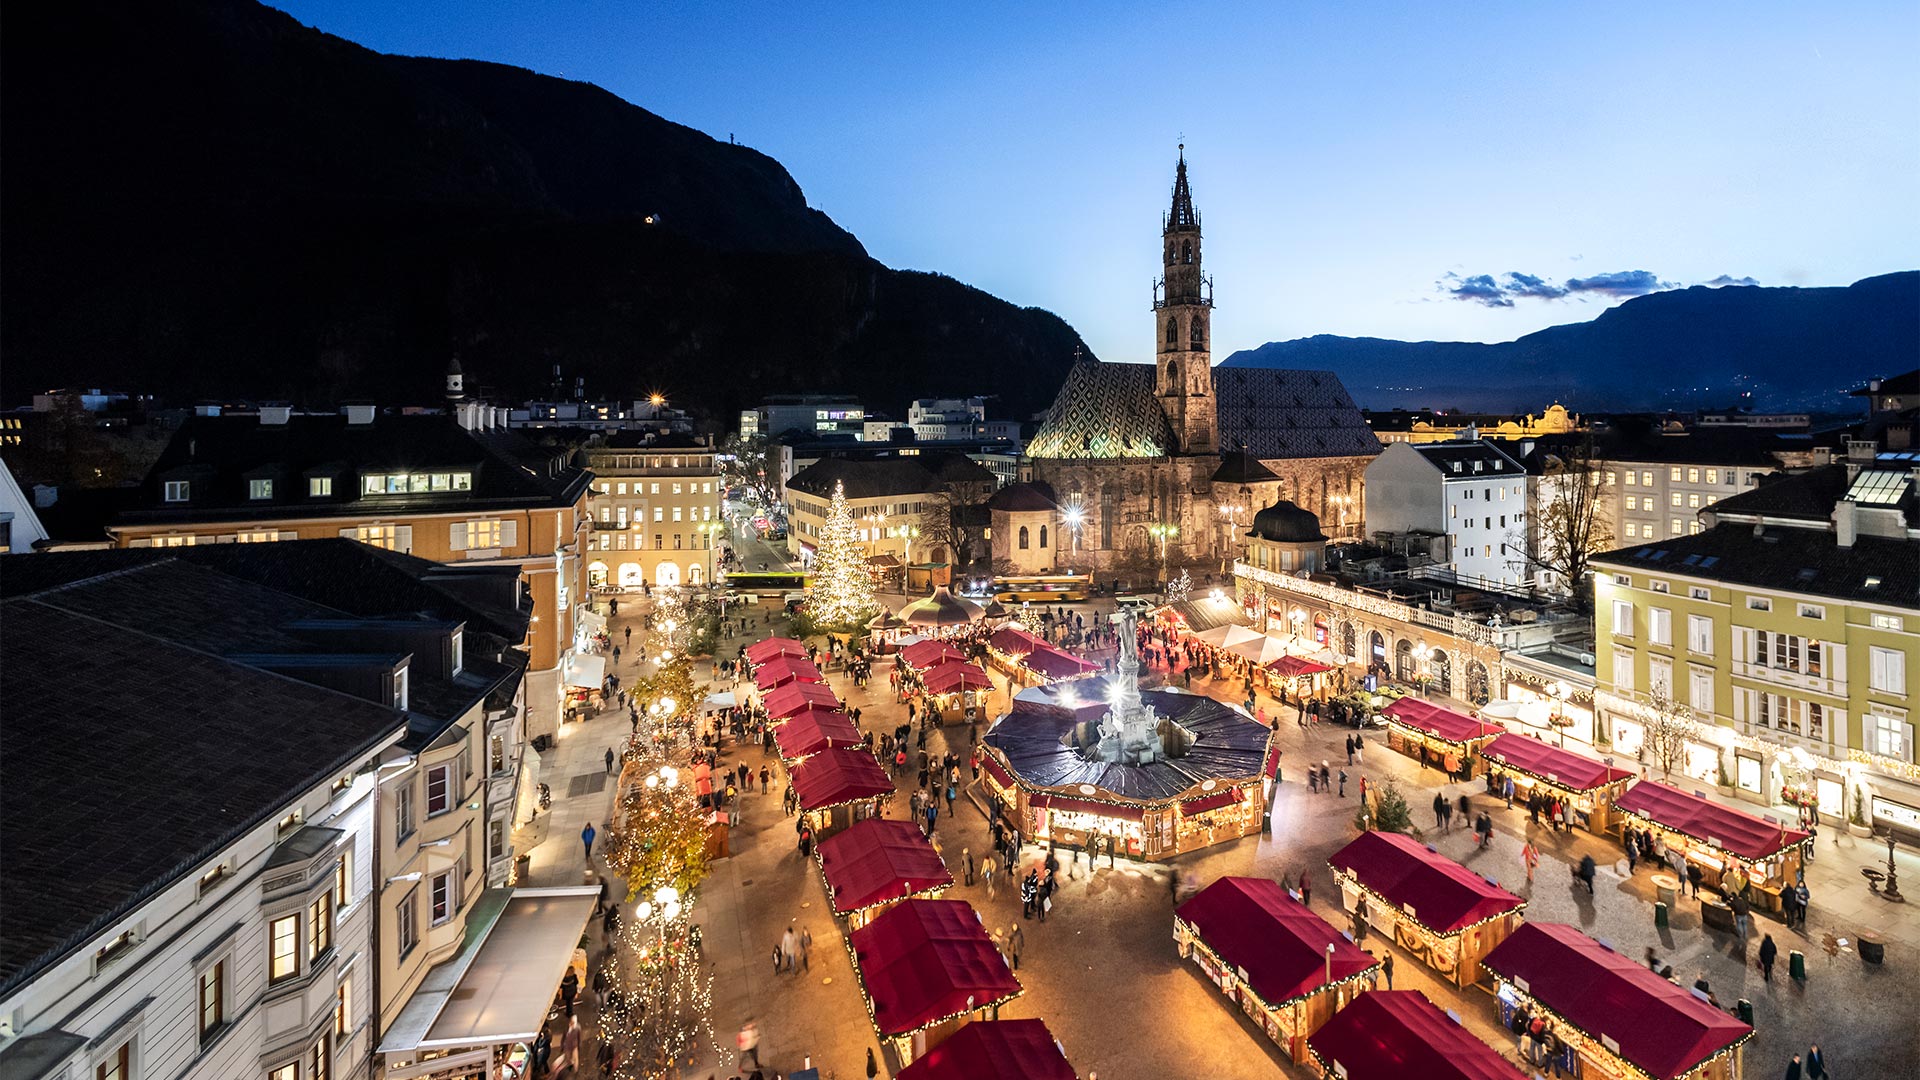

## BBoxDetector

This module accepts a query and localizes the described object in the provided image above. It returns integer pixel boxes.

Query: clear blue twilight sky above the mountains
[278,0,1920,359]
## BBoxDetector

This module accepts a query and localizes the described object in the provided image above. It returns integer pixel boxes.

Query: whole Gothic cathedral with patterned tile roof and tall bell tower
[1027,146,1380,573]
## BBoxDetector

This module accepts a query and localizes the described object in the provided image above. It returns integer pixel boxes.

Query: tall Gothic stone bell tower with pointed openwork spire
[1154,144,1219,454]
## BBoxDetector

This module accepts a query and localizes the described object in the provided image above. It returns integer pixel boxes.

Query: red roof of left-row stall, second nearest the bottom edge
[852,899,1020,1036]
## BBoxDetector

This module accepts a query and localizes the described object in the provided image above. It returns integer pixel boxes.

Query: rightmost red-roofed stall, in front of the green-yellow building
[1613,780,1809,911]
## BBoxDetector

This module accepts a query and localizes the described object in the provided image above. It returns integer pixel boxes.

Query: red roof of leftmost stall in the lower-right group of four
[1173,878,1380,1005]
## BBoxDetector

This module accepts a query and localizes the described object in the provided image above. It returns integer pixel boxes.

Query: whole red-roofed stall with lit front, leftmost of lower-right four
[1173,878,1380,1065]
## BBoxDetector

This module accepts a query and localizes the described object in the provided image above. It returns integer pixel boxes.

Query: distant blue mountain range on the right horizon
[1223,271,1920,411]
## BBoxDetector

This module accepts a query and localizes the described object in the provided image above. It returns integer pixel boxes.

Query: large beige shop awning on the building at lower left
[380,886,599,1053]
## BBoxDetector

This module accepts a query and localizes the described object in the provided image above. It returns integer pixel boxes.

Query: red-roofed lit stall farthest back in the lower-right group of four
[1329,830,1526,988]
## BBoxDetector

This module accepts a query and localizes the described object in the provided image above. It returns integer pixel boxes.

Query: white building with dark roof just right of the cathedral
[1367,440,1532,588]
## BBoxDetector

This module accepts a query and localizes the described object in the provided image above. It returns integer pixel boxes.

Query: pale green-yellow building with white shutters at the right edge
[1596,444,1920,822]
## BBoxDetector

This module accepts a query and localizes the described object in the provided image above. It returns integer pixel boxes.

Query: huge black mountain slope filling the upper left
[0,0,1079,415]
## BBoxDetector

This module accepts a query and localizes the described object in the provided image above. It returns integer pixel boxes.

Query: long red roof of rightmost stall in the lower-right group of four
[1480,922,1753,1080]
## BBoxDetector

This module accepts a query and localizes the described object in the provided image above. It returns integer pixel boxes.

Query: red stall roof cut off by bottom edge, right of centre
[1308,990,1524,1080]
